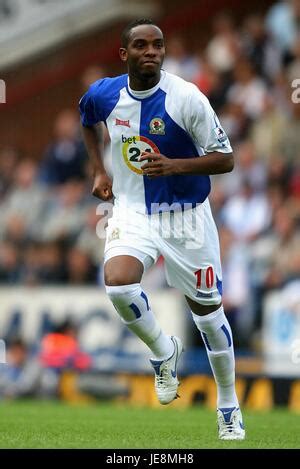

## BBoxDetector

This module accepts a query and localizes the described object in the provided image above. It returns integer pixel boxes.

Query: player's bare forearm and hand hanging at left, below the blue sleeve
[81,124,113,200]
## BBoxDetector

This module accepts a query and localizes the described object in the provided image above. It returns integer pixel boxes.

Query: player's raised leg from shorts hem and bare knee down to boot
[104,248,182,404]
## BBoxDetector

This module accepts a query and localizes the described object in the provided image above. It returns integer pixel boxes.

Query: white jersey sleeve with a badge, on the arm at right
[189,85,232,154]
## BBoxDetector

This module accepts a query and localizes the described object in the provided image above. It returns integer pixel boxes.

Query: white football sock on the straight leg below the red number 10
[192,306,238,408]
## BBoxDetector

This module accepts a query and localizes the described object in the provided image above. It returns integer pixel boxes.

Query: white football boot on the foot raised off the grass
[150,336,183,405]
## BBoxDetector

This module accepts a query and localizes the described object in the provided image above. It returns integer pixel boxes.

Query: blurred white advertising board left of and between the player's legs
[0,287,187,364]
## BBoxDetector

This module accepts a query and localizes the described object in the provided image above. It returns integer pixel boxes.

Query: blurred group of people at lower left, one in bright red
[0,318,128,402]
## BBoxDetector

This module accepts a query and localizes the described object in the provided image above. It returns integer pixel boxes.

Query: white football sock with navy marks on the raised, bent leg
[105,283,174,360]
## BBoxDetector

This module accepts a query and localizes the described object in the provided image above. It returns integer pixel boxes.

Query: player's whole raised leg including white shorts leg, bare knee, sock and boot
[104,207,182,404]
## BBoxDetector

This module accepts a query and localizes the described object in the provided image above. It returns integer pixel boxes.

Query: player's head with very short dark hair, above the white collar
[120,25,165,78]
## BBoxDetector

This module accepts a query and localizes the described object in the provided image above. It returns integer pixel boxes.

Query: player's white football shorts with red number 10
[104,199,222,305]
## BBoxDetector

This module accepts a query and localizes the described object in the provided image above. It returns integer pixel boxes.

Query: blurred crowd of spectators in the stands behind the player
[0,0,300,348]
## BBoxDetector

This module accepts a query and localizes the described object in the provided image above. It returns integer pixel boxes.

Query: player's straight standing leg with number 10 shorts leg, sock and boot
[162,201,244,439]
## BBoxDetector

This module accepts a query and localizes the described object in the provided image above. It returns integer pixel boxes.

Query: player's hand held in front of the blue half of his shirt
[139,151,176,178]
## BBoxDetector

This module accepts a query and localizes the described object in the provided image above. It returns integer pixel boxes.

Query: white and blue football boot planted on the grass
[217,407,245,440]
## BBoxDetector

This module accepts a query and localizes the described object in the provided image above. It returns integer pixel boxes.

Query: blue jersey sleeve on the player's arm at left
[79,80,104,127]
